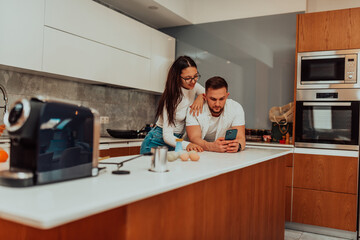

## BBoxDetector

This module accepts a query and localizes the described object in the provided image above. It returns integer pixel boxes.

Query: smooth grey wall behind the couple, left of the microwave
[162,13,296,129]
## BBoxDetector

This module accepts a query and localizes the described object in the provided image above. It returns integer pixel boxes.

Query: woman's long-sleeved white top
[156,83,205,149]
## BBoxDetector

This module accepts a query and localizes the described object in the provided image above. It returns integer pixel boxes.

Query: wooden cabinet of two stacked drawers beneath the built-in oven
[291,153,358,232]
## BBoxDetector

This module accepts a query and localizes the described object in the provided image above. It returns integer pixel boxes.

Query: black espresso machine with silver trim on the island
[0,97,100,187]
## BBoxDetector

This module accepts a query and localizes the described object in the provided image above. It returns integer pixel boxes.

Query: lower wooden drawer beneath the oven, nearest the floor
[292,188,357,232]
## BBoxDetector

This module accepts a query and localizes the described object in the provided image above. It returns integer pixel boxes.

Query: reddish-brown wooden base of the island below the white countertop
[0,154,285,240]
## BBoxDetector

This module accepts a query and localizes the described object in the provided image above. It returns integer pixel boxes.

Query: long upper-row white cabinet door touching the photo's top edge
[45,0,151,58]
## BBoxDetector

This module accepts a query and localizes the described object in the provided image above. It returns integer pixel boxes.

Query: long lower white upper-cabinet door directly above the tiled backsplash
[43,27,150,89]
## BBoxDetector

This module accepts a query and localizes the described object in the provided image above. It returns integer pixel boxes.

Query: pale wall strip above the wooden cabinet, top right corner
[306,0,360,13]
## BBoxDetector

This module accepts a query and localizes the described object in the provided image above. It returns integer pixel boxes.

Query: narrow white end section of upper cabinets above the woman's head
[149,29,175,92]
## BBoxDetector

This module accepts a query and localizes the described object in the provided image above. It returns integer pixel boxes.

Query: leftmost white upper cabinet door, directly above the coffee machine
[0,0,45,71]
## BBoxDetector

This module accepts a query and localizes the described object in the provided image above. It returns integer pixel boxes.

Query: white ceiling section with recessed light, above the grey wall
[94,0,306,29]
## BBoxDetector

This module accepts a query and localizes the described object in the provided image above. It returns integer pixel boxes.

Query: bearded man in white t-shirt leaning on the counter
[186,77,245,152]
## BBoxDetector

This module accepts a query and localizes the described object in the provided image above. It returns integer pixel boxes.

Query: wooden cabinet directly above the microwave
[297,8,360,52]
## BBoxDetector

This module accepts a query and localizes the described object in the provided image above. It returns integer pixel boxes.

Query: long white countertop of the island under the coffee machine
[0,147,292,229]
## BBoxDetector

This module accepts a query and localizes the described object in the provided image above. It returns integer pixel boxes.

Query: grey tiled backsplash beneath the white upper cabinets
[0,70,159,136]
